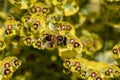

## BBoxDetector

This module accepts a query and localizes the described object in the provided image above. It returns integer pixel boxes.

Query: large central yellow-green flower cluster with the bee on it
[0,0,101,54]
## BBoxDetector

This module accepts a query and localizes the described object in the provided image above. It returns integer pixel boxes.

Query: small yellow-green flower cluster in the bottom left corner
[0,57,21,80]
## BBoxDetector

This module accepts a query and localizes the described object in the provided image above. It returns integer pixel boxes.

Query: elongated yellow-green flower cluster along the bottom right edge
[63,58,120,80]
